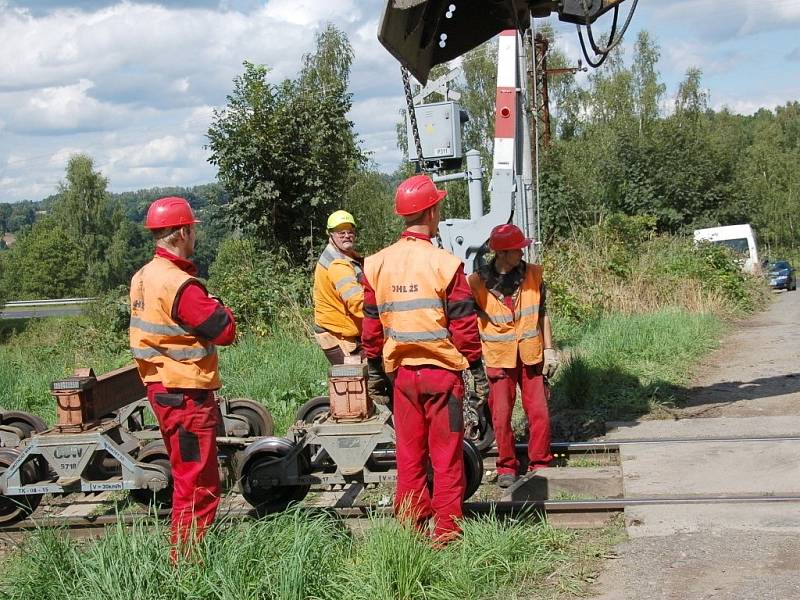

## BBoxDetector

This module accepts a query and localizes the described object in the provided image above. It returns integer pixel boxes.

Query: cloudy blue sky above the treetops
[0,0,800,201]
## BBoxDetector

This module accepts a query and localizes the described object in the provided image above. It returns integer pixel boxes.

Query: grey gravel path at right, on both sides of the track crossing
[589,293,800,600]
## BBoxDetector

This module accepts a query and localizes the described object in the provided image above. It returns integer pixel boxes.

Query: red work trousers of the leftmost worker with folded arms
[147,384,222,561]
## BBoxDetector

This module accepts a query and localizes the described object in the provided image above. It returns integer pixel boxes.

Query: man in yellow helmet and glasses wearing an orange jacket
[314,210,364,365]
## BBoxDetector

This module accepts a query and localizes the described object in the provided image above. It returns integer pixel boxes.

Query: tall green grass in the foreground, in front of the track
[0,511,610,600]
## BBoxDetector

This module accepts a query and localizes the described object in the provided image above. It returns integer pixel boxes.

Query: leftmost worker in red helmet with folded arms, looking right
[130,197,236,562]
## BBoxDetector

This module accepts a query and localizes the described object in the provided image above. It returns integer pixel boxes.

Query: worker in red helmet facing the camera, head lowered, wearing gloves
[469,225,559,487]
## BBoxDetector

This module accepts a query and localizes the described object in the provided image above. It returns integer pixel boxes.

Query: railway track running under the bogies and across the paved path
[0,436,800,543]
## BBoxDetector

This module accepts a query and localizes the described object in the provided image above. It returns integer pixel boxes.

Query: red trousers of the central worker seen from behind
[393,366,465,540]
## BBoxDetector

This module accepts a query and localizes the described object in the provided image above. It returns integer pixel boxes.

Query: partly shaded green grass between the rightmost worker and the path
[551,309,725,420]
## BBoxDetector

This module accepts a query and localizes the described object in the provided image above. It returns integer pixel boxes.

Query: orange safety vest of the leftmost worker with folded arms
[130,256,220,390]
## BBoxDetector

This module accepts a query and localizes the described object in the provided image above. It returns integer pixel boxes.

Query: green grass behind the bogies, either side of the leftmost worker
[0,317,328,433]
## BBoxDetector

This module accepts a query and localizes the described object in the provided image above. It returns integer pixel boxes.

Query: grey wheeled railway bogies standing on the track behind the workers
[0,366,483,526]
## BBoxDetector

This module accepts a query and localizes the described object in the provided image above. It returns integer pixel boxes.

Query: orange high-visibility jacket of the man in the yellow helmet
[314,244,364,337]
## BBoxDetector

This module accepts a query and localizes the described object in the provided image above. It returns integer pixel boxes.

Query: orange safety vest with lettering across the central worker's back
[364,237,468,373]
